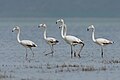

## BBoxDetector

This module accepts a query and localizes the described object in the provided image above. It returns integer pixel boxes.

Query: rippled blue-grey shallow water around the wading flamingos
[0,18,120,80]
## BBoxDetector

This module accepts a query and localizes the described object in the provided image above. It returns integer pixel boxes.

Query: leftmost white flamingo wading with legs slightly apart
[12,26,37,59]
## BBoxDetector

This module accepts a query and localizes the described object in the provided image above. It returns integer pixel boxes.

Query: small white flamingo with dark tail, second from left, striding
[38,24,59,56]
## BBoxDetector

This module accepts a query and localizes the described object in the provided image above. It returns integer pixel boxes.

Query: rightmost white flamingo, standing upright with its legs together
[87,25,114,58]
